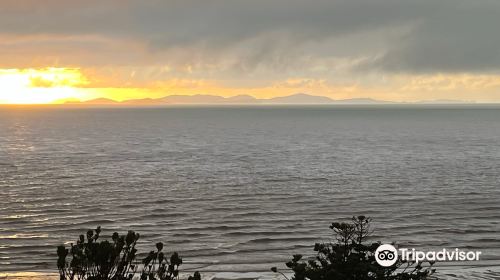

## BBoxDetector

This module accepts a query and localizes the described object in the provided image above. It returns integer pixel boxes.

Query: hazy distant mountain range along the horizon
[64,93,472,106]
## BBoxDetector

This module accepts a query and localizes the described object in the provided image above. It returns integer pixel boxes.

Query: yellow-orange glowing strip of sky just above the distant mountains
[0,67,500,104]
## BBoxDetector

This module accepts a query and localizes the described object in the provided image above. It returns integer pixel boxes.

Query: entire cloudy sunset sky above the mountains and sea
[0,0,500,103]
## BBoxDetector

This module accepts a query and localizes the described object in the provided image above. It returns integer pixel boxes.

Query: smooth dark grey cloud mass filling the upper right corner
[365,0,500,73]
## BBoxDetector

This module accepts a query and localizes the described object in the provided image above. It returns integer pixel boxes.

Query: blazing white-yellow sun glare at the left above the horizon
[0,67,88,104]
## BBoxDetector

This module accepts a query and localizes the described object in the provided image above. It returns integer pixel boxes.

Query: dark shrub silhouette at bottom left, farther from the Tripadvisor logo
[57,227,201,280]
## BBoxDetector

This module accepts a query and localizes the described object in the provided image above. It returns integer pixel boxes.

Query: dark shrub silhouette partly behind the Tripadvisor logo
[271,216,435,280]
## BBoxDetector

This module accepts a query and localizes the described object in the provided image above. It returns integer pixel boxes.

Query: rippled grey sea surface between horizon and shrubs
[0,105,500,279]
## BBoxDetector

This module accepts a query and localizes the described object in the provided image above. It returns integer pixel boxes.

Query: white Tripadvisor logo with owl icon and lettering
[375,244,481,267]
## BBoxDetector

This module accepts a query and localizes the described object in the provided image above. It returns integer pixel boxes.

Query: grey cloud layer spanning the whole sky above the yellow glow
[0,0,500,72]
